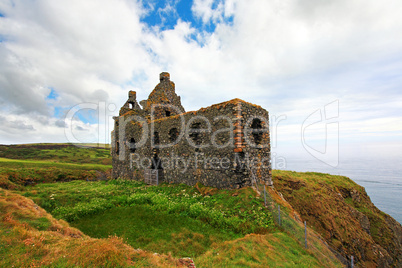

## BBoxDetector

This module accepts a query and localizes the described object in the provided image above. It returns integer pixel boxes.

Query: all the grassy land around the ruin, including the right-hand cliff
[0,144,402,267]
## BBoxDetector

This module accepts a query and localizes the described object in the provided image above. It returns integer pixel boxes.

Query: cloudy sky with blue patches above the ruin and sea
[0,0,402,164]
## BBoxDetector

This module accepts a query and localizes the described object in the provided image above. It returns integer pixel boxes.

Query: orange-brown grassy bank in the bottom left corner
[0,188,183,267]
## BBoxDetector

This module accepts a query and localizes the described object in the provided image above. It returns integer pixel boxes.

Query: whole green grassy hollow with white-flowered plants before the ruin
[13,180,274,256]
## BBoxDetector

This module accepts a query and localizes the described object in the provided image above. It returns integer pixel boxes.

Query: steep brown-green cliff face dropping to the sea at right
[273,171,402,267]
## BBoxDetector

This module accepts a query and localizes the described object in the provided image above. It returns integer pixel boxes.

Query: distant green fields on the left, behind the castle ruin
[0,144,112,189]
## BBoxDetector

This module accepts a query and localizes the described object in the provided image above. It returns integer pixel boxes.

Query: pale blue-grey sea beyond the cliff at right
[274,156,402,223]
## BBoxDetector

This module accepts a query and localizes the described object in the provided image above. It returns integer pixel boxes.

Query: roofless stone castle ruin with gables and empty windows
[111,72,272,189]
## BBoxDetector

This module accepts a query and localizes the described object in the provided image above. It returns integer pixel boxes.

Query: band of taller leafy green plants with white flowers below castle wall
[21,180,273,233]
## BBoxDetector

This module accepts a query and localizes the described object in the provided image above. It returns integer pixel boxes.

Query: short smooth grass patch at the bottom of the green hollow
[72,205,241,257]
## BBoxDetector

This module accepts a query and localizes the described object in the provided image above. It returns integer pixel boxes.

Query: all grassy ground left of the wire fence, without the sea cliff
[0,144,362,267]
